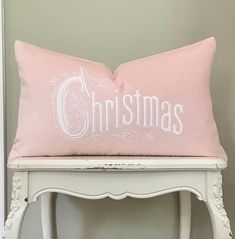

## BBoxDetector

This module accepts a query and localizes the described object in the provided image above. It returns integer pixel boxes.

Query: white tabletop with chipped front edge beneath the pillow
[8,156,227,171]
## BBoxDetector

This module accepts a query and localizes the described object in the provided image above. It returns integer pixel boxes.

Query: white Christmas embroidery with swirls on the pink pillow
[53,68,183,142]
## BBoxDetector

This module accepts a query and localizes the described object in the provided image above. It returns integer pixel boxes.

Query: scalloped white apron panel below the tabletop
[28,171,206,203]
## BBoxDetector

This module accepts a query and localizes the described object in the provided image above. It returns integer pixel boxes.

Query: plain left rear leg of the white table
[41,193,54,239]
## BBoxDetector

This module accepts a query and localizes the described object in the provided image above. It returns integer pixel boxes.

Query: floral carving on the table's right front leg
[213,173,230,230]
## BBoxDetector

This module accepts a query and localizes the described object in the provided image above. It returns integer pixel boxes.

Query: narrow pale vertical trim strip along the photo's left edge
[0,0,6,235]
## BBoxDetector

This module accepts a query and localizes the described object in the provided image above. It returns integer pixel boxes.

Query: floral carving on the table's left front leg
[3,176,22,239]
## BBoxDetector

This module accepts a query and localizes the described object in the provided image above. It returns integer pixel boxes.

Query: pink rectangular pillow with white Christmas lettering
[10,38,226,159]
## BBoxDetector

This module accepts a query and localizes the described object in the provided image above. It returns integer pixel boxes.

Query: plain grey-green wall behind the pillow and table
[5,0,235,239]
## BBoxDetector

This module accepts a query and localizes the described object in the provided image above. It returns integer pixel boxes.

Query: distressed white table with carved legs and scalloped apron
[3,156,232,239]
